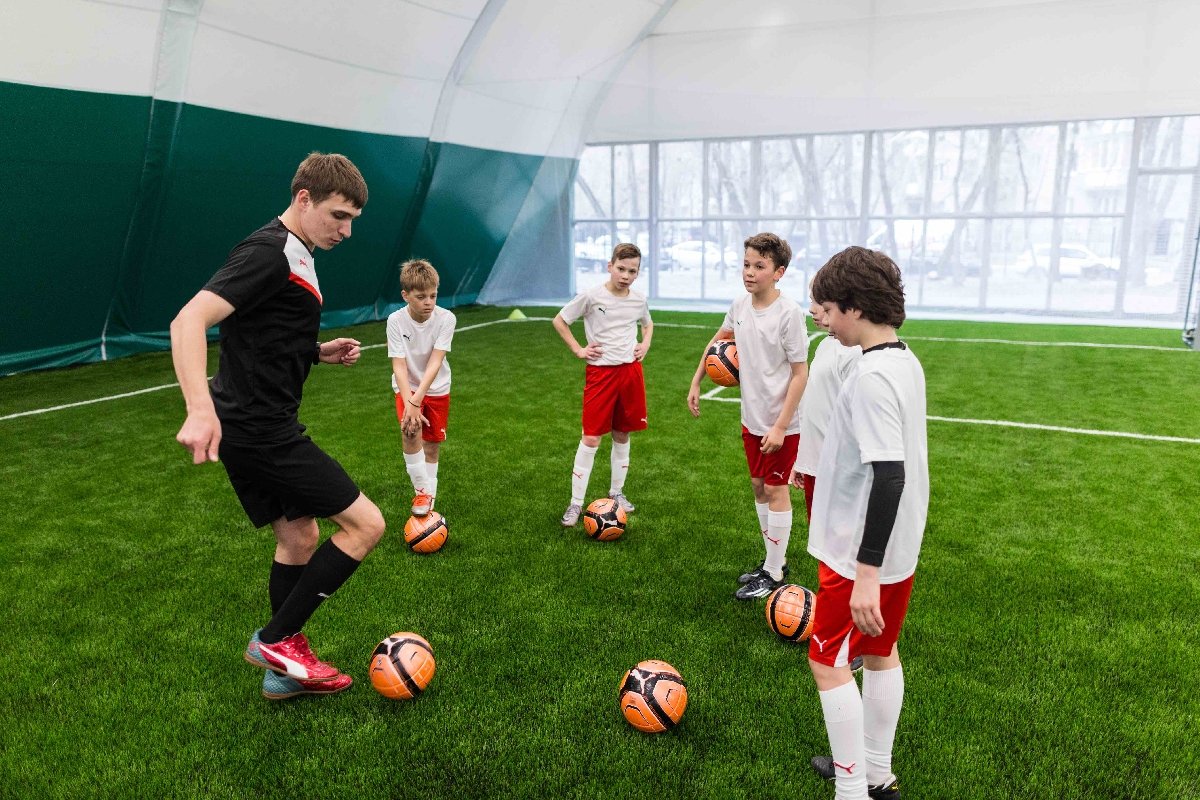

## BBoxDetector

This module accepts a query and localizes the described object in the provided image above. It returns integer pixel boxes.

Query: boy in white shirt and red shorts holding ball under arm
[688,233,809,600]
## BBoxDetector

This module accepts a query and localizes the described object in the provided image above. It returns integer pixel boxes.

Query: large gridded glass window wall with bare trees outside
[574,116,1200,320]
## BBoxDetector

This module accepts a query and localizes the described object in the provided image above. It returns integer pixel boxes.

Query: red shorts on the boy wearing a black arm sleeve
[809,563,912,667]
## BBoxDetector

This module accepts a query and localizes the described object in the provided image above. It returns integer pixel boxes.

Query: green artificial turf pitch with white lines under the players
[0,308,1200,799]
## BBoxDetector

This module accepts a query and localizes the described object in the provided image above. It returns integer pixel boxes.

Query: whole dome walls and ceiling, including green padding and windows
[0,0,1200,374]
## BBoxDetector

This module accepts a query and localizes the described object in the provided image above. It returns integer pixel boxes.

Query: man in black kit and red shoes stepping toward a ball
[170,152,384,699]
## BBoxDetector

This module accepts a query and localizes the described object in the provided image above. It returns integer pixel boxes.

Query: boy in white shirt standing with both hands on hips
[554,242,654,528]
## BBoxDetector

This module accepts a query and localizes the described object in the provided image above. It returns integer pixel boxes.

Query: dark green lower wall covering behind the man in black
[0,82,574,374]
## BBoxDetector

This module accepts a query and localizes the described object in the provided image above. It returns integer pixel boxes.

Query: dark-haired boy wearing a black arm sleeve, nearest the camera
[809,247,929,800]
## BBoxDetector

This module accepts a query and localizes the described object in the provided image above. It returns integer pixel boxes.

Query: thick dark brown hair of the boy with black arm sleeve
[812,247,905,327]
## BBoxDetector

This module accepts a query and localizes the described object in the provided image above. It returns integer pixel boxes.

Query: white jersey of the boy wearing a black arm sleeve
[809,347,929,583]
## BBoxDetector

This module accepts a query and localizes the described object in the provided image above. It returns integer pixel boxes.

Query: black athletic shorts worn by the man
[220,434,359,528]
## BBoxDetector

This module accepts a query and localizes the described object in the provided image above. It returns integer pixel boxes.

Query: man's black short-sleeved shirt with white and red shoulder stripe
[204,217,322,443]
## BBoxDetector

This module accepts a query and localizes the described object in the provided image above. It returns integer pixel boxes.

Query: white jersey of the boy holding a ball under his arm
[721,294,809,437]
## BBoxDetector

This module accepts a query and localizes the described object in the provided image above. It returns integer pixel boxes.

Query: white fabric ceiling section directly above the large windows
[587,0,1200,144]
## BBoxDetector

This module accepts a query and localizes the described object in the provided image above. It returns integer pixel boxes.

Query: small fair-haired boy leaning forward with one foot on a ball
[388,259,457,517]
